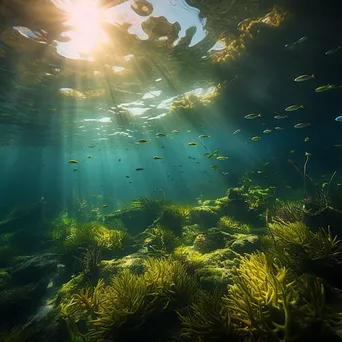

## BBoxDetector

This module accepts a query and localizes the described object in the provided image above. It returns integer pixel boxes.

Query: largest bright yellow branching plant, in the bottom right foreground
[224,252,339,342]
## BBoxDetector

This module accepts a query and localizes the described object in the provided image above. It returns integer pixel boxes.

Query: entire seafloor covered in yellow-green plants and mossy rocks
[0,175,342,342]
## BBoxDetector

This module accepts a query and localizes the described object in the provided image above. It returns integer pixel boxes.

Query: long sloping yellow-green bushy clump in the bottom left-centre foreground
[60,258,198,341]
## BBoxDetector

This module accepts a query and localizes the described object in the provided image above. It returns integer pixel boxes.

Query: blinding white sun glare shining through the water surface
[64,0,107,54]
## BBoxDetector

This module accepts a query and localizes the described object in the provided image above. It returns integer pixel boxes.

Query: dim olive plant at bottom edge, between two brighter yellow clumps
[178,291,234,342]
